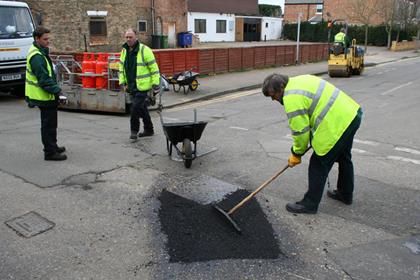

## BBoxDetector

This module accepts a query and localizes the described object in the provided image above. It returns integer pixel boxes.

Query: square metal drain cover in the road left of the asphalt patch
[5,211,55,238]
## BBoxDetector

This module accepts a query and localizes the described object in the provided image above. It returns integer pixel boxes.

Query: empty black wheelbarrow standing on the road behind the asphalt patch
[158,94,207,168]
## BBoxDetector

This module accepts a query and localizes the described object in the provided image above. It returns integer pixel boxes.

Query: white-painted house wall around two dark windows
[188,12,235,42]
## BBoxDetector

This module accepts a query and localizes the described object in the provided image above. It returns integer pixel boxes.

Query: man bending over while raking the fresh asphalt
[262,74,362,214]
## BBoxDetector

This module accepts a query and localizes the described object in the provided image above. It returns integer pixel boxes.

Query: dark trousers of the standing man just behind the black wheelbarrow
[130,91,153,133]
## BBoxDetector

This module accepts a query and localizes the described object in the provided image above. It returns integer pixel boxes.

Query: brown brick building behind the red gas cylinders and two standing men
[26,0,187,52]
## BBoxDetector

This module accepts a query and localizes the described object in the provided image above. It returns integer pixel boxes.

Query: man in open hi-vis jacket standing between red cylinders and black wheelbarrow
[119,29,160,140]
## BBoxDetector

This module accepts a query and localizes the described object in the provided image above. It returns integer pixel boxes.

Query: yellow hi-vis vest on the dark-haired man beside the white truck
[25,45,55,101]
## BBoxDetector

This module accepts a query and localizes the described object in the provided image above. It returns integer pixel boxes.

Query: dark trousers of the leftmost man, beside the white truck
[39,106,57,155]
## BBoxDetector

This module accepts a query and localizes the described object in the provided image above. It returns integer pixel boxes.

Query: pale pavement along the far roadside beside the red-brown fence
[155,46,420,110]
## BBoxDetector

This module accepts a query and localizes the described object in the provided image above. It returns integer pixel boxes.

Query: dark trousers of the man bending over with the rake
[301,110,362,209]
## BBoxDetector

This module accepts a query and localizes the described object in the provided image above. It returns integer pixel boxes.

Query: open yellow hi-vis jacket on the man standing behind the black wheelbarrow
[119,44,160,91]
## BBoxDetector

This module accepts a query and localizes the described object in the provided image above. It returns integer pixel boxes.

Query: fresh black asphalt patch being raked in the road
[158,190,283,263]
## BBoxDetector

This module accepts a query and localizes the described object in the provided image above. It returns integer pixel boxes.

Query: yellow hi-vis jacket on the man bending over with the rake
[283,75,360,156]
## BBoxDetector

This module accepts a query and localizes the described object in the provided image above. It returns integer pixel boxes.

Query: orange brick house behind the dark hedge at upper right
[284,0,382,25]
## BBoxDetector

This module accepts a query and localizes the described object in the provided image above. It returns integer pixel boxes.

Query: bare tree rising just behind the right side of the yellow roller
[346,0,382,53]
